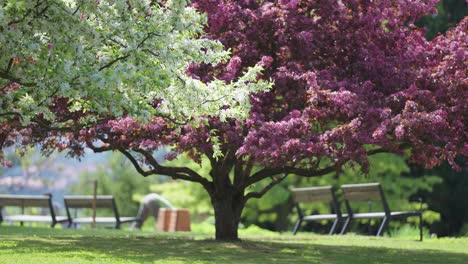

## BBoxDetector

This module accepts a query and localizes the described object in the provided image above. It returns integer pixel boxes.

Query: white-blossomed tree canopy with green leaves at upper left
[0,0,270,160]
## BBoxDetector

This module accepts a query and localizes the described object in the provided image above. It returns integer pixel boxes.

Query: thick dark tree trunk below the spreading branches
[210,191,244,241]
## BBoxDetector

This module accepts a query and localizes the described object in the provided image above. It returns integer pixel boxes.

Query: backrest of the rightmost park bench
[341,183,390,214]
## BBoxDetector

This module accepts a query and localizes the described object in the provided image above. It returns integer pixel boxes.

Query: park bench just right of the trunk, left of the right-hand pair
[292,186,343,235]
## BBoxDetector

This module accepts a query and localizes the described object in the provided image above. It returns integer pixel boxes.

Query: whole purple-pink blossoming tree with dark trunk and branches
[1,0,468,240]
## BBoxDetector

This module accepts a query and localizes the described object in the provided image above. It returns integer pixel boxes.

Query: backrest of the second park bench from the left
[63,195,119,220]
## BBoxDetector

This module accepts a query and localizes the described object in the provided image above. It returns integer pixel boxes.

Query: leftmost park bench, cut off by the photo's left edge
[0,194,68,227]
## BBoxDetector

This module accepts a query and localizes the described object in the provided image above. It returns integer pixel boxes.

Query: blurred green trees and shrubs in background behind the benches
[0,0,468,236]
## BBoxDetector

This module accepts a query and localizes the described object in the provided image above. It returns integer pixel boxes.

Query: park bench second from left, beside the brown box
[64,195,139,229]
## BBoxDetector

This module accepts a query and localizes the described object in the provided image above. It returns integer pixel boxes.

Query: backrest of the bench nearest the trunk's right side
[291,186,341,216]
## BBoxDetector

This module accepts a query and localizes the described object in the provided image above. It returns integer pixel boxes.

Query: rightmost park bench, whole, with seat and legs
[341,183,422,241]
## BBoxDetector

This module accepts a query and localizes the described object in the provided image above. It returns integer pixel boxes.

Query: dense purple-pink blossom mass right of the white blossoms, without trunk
[183,0,468,169]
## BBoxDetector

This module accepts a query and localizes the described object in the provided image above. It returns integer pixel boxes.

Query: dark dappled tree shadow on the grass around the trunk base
[0,236,468,264]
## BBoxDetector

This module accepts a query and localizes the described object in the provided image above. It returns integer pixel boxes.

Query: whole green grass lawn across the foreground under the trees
[0,225,468,264]
